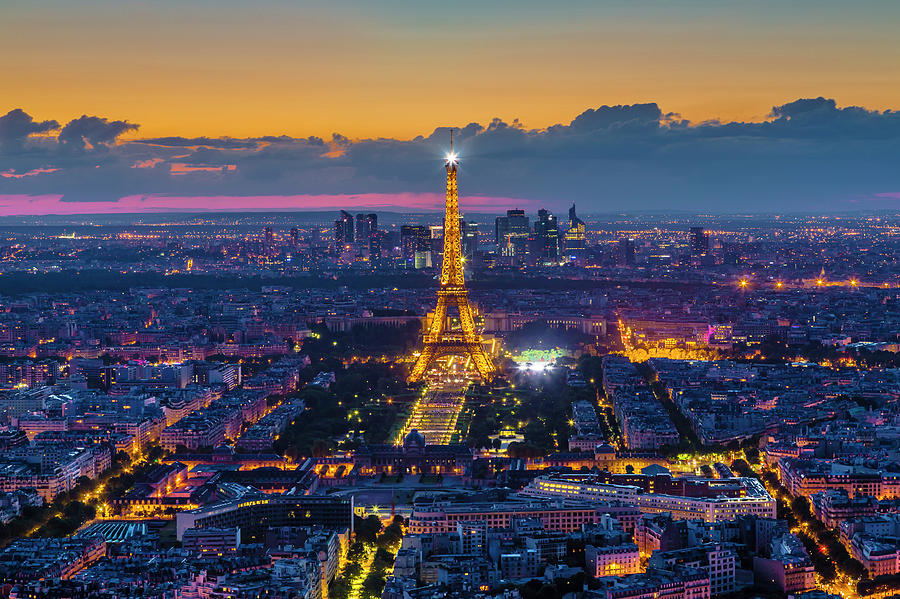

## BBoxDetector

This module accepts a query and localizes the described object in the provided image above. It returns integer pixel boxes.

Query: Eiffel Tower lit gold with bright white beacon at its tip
[409,131,494,382]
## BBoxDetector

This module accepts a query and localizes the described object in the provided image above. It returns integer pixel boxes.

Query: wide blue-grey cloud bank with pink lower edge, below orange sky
[0,97,900,214]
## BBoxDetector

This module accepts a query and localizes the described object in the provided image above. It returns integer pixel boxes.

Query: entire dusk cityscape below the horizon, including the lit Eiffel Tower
[0,205,900,599]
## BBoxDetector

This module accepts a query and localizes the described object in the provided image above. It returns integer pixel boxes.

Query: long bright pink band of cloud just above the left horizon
[0,193,539,216]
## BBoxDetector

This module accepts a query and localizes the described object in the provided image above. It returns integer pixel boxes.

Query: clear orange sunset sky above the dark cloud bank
[0,0,900,138]
